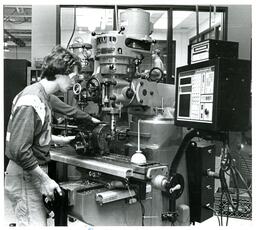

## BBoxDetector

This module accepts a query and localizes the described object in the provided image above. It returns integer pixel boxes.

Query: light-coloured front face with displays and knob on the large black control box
[177,66,215,123]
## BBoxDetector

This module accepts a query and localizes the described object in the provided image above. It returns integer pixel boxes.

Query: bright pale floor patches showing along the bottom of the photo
[4,192,253,229]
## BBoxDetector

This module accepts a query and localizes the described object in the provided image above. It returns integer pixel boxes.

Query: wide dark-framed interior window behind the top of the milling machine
[59,5,227,84]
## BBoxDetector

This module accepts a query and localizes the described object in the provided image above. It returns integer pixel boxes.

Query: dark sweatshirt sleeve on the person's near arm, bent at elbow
[8,106,42,170]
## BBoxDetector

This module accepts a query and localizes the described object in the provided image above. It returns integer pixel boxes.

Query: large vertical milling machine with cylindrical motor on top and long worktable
[50,9,190,226]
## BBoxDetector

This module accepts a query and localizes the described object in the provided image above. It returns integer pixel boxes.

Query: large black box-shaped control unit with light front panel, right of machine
[174,58,251,131]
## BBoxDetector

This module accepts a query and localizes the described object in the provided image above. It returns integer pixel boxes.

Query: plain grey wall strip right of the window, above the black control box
[227,5,252,59]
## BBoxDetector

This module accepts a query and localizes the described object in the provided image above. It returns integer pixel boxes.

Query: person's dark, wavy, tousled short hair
[41,46,81,81]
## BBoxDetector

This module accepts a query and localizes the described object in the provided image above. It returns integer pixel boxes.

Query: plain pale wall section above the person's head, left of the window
[31,5,56,66]
